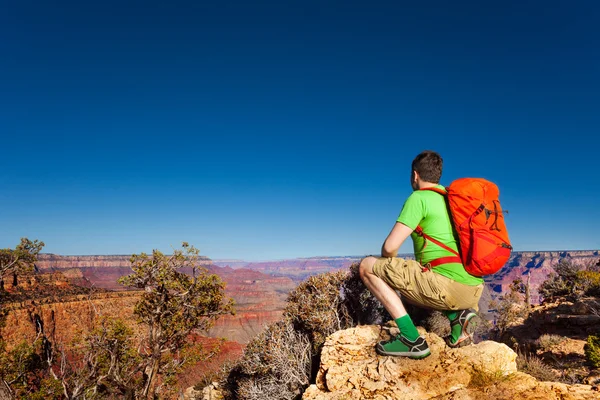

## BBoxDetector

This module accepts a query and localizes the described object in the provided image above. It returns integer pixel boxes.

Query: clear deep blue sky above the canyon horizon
[0,0,600,260]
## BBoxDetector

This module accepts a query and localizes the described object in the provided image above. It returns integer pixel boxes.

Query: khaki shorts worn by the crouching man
[373,257,483,310]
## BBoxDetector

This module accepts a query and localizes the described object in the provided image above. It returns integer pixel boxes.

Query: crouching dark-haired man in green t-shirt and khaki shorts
[360,151,483,358]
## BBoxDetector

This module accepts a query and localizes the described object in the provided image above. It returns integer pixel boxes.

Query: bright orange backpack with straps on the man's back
[415,178,512,277]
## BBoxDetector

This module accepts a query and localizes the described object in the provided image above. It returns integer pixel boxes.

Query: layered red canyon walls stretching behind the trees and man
[2,250,600,394]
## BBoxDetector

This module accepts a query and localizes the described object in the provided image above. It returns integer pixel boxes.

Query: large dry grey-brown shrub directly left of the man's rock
[222,264,389,400]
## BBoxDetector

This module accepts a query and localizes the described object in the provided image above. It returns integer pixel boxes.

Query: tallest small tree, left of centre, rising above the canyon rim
[119,242,233,398]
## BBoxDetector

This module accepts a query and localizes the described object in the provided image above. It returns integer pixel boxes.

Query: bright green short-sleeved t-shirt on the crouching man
[397,185,483,286]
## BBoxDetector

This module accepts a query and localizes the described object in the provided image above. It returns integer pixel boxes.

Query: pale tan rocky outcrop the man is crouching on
[302,326,600,400]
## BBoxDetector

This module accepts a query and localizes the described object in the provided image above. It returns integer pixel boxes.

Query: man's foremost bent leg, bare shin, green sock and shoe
[359,257,430,358]
